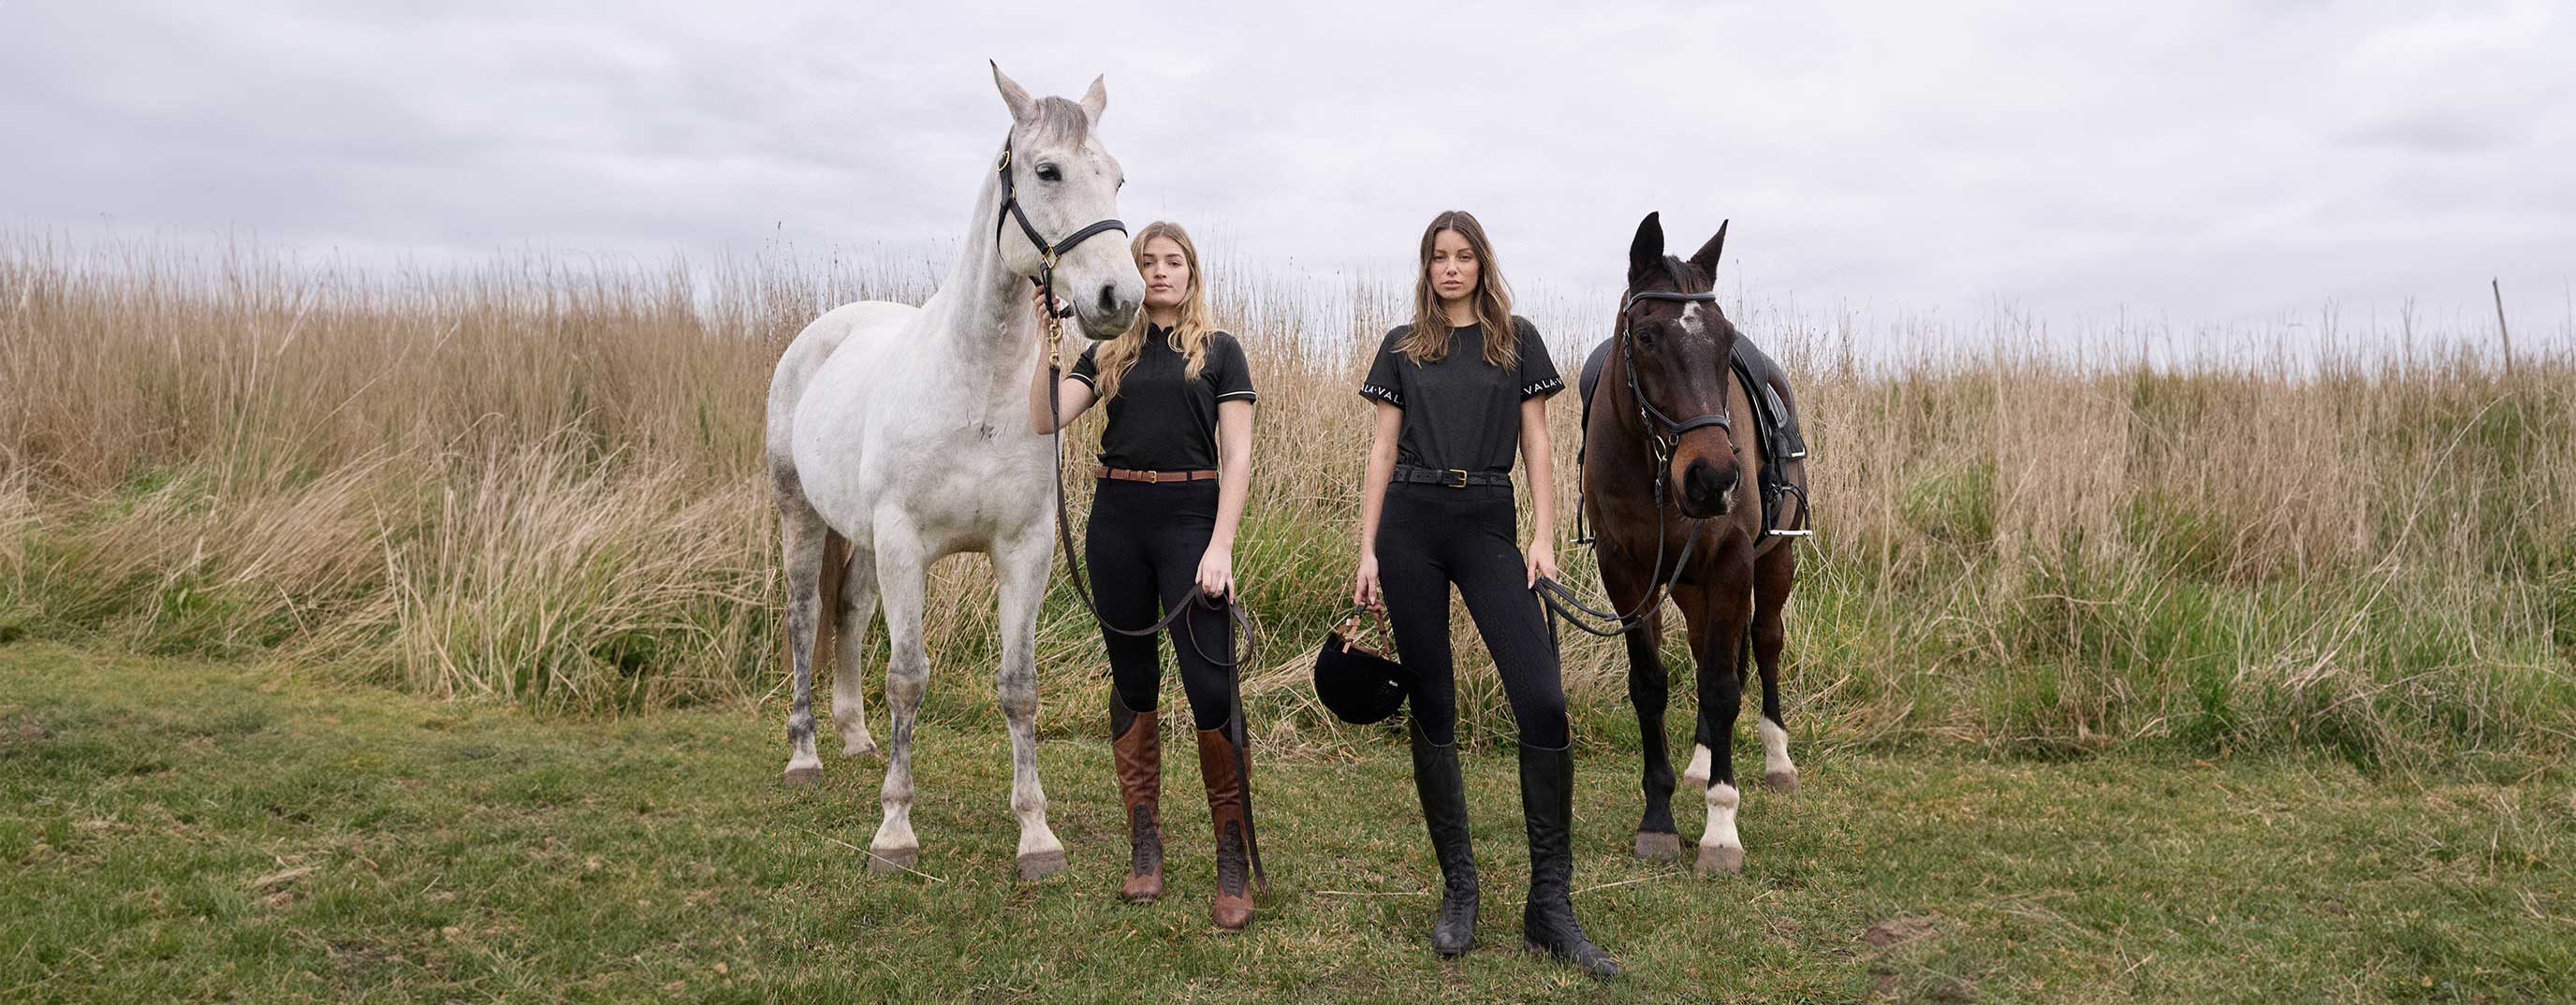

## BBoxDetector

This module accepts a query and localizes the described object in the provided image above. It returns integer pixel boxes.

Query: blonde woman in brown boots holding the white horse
[1028,222,1257,930]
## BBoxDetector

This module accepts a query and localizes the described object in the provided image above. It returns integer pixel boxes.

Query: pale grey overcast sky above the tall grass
[0,0,2576,338]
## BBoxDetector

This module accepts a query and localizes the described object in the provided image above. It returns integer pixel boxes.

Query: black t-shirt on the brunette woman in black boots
[1360,314,1566,472]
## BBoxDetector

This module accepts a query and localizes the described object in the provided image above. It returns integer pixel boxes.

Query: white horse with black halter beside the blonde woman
[768,67,1144,879]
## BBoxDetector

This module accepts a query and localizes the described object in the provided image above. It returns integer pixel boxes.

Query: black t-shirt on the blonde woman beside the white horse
[1069,328,1254,472]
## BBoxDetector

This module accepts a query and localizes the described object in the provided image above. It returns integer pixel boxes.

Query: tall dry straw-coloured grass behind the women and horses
[0,235,2576,770]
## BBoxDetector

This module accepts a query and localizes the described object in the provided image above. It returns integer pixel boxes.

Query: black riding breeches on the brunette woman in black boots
[1378,482,1569,748]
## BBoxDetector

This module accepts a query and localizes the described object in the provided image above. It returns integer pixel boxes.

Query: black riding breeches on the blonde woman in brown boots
[1082,479,1234,729]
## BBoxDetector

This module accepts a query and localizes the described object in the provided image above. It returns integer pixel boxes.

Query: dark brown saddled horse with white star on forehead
[1582,214,1808,876]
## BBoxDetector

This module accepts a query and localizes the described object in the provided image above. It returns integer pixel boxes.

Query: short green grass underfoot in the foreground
[0,642,2576,1002]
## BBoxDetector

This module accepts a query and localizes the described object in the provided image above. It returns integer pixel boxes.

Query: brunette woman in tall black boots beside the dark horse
[1353,211,1617,977]
